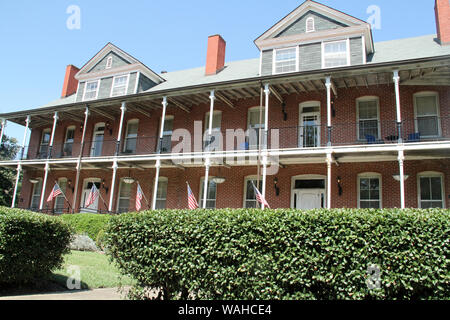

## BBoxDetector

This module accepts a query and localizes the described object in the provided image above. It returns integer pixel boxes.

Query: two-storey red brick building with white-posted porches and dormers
[0,0,450,213]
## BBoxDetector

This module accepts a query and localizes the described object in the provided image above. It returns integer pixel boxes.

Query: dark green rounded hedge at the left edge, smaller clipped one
[0,207,72,284]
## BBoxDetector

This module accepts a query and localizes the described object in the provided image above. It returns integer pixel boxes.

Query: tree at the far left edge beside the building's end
[0,135,20,206]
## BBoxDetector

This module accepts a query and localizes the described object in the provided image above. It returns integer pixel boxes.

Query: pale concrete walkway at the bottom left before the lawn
[0,288,126,300]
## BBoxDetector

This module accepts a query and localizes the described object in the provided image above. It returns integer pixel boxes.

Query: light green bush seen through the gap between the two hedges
[60,213,111,240]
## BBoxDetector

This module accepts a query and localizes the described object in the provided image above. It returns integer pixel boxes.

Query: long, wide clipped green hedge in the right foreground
[106,209,450,300]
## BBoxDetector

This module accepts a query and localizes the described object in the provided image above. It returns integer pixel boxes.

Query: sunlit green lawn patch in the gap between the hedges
[53,251,133,289]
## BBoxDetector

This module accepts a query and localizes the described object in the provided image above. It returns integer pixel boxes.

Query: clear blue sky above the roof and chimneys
[0,0,436,141]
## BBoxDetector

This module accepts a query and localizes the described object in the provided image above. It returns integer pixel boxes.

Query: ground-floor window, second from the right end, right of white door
[358,174,381,209]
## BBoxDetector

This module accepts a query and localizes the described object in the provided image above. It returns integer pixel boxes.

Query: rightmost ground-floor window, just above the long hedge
[418,172,445,209]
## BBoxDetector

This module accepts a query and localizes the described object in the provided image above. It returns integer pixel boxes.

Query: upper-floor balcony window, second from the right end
[357,98,380,141]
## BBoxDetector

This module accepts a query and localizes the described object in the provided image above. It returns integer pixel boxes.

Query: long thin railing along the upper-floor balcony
[8,116,450,160]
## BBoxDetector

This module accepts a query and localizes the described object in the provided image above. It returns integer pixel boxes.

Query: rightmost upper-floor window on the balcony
[414,93,440,137]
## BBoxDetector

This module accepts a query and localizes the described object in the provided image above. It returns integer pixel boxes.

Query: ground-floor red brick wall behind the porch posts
[19,159,450,210]
